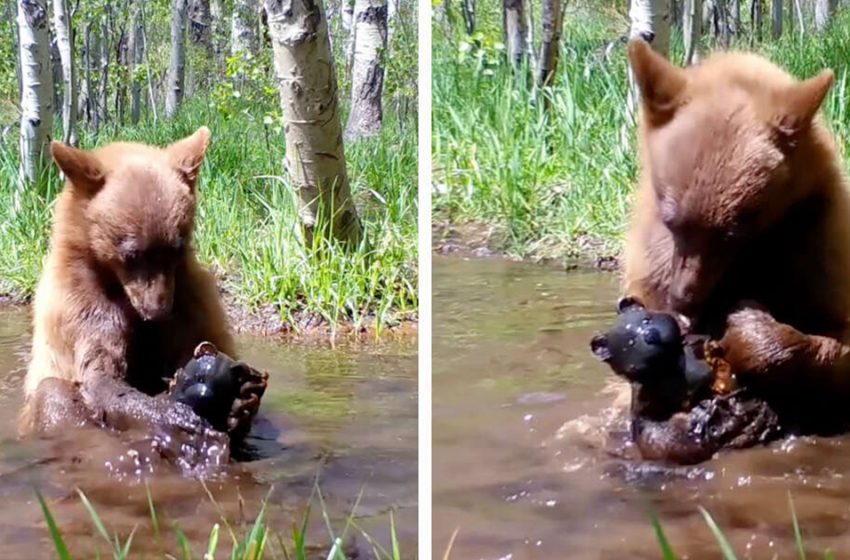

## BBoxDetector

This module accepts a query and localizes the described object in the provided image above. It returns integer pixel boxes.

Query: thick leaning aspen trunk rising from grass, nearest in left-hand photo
[265,0,361,247]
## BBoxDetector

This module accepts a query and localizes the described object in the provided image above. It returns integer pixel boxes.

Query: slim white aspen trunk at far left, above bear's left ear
[18,0,53,182]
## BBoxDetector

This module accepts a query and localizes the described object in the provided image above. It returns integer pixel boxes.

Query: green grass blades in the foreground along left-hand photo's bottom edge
[36,476,402,560]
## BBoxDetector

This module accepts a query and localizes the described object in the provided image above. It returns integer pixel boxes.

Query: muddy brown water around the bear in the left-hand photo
[0,310,417,558]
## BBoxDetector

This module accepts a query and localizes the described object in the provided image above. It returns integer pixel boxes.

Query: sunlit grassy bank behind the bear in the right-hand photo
[432,2,850,266]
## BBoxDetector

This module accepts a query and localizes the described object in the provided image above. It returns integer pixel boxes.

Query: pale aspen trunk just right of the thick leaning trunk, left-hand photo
[345,0,387,140]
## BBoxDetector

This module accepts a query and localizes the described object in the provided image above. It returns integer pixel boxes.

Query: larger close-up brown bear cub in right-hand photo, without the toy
[623,41,850,433]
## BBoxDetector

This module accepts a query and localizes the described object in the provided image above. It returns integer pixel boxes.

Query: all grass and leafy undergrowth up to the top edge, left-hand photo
[0,0,418,329]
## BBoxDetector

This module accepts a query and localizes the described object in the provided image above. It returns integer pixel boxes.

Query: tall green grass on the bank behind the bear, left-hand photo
[0,97,418,329]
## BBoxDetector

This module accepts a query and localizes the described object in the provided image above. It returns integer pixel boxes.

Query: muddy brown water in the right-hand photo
[433,258,850,560]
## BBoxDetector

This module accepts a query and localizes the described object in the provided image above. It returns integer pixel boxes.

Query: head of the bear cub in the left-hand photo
[50,127,210,321]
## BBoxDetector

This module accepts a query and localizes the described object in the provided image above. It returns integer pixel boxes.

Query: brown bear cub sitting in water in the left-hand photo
[21,127,255,442]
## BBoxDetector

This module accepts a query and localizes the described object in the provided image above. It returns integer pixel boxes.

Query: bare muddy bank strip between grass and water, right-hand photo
[431,216,621,270]
